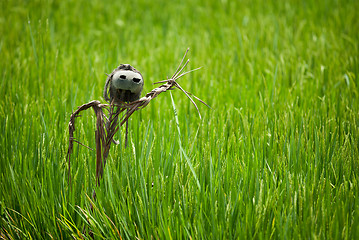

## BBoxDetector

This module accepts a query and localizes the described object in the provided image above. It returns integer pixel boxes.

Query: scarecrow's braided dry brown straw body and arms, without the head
[67,49,209,185]
